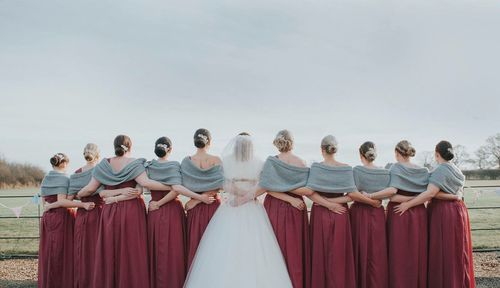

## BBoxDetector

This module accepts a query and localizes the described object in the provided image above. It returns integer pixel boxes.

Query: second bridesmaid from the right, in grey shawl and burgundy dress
[368,140,429,288]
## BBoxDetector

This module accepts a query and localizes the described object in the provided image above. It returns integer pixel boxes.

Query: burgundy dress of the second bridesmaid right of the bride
[311,193,356,288]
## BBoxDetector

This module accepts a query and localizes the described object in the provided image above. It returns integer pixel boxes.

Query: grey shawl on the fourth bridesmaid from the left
[145,160,182,185]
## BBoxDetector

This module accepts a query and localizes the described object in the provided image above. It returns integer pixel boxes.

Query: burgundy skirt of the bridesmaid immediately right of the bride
[264,193,311,288]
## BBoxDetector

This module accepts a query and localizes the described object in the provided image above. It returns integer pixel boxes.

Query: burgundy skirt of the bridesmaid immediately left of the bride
[187,196,220,269]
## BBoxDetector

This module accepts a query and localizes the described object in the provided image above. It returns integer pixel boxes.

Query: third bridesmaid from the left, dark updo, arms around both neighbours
[79,135,191,287]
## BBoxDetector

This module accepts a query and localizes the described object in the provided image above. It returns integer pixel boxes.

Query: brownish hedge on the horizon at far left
[0,156,45,189]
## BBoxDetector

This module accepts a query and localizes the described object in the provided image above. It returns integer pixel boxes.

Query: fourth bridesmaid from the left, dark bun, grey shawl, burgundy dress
[146,137,213,288]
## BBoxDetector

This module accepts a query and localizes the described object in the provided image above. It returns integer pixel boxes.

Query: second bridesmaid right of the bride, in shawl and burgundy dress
[298,135,358,288]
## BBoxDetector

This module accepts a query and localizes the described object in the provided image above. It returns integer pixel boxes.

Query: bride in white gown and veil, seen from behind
[184,133,292,288]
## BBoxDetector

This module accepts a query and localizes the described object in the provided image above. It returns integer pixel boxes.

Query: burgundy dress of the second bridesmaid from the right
[387,190,427,288]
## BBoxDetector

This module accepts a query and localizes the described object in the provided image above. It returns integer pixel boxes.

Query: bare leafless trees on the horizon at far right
[419,133,500,172]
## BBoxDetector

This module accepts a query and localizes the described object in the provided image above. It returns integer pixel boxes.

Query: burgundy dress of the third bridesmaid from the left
[93,180,149,288]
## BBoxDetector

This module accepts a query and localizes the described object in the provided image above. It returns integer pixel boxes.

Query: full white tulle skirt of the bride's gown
[185,201,292,288]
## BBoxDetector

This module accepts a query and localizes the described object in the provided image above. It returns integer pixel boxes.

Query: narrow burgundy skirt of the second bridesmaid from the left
[74,194,103,288]
